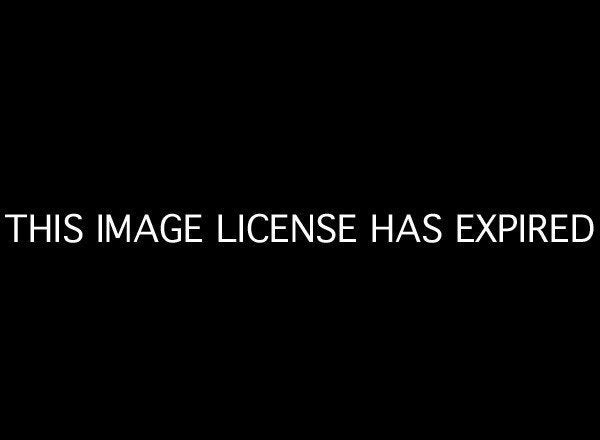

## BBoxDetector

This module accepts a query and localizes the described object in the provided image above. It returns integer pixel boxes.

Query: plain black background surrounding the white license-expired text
[1,5,598,433]
